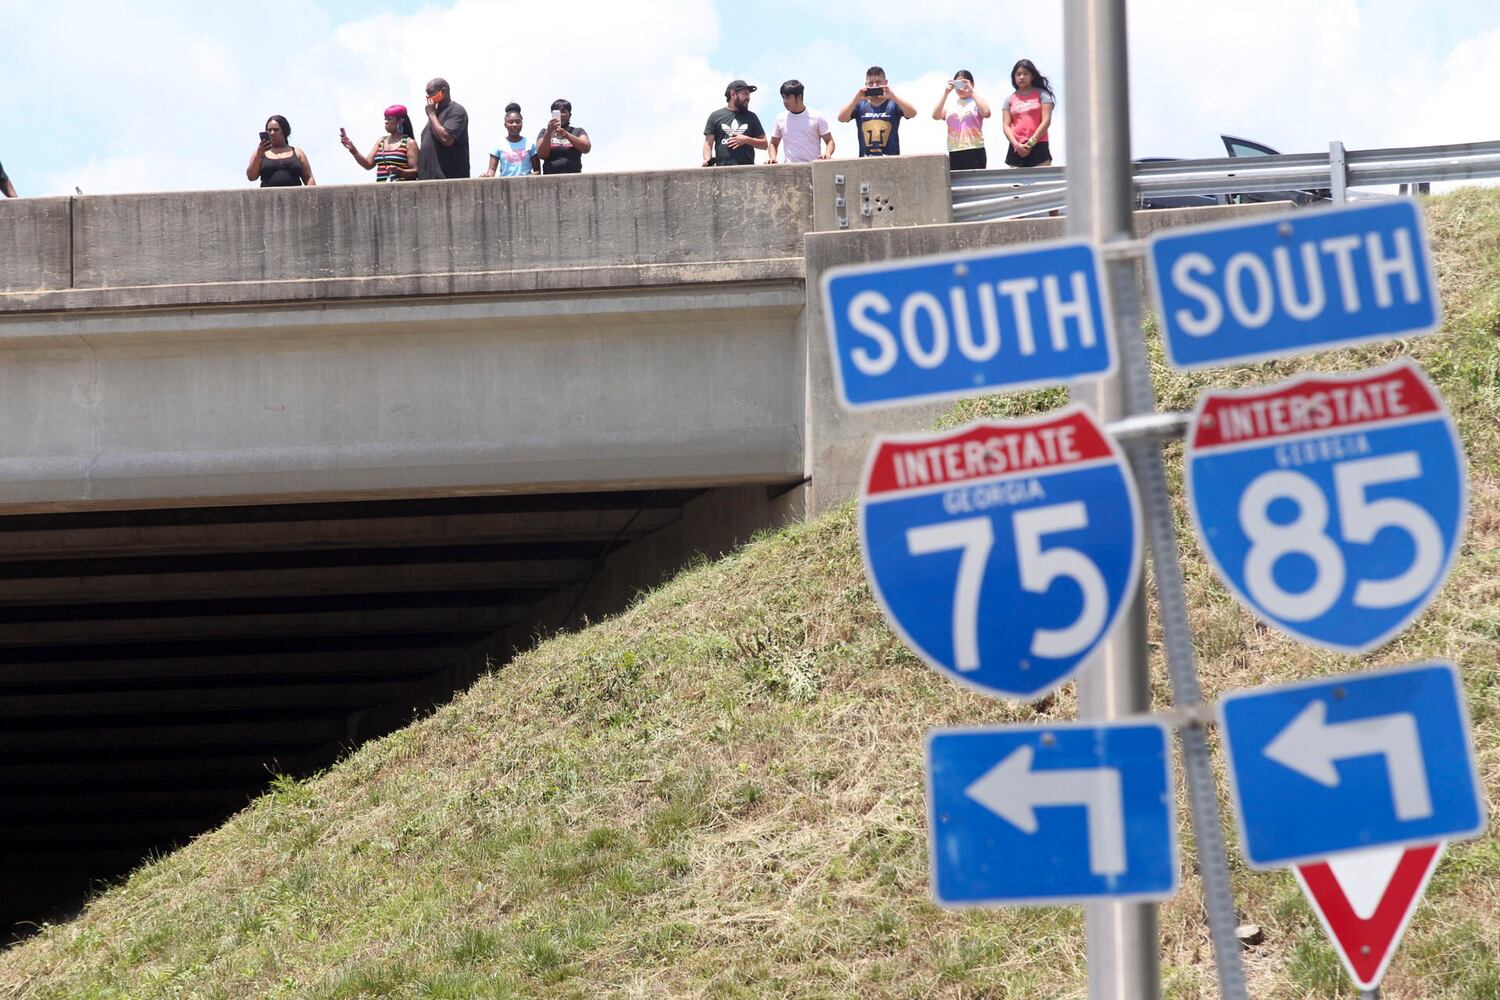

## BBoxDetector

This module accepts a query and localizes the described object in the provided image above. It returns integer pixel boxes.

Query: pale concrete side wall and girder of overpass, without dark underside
[0,156,1266,521]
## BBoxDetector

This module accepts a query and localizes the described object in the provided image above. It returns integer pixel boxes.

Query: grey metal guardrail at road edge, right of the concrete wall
[953,141,1500,222]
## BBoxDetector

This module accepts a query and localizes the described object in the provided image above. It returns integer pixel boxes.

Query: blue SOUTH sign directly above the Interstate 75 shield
[822,241,1115,409]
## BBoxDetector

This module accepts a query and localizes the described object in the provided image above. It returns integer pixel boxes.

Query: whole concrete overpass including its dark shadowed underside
[0,157,1242,928]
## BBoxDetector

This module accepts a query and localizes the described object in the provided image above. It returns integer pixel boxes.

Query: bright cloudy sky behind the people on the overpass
[0,0,1500,196]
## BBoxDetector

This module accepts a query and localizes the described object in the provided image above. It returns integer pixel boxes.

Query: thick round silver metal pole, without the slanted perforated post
[1062,7,1161,1000]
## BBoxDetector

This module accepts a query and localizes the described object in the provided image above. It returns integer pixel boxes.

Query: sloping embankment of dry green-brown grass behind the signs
[0,185,1500,1000]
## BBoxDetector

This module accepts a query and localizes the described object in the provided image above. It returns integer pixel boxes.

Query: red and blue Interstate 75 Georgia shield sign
[860,406,1142,699]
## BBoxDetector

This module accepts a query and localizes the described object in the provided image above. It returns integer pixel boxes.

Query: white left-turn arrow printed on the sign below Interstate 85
[1265,699,1433,820]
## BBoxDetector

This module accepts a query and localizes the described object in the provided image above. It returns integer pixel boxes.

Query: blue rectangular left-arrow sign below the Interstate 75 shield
[927,721,1178,906]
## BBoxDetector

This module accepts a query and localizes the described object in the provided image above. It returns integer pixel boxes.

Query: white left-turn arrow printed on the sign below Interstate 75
[965,747,1125,876]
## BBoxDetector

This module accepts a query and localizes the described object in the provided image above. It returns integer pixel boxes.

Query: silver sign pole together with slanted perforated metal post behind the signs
[1064,0,1247,1000]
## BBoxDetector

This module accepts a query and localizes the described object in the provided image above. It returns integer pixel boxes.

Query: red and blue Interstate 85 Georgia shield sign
[1187,361,1469,654]
